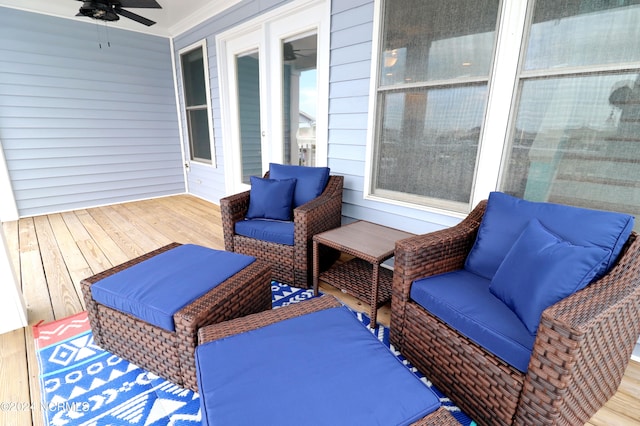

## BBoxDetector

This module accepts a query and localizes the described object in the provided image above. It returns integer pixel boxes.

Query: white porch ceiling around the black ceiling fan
[0,0,240,37]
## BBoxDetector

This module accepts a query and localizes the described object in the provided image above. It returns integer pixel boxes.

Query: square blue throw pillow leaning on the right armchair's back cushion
[489,219,611,334]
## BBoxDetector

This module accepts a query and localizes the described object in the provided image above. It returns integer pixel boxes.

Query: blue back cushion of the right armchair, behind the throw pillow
[465,192,634,279]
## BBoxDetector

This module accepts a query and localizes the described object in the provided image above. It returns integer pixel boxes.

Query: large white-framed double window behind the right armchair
[369,0,640,223]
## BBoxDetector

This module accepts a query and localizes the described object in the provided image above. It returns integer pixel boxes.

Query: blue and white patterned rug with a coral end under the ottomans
[34,282,473,426]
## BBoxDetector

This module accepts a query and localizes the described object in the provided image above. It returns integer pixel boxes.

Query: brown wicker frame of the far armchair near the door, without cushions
[220,172,344,288]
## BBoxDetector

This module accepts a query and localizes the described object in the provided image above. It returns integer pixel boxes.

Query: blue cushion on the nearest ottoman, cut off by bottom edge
[196,302,440,426]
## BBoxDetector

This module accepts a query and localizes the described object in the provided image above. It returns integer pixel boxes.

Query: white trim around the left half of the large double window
[363,0,530,218]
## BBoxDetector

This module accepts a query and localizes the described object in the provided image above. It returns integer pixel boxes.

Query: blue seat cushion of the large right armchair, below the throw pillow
[410,269,535,372]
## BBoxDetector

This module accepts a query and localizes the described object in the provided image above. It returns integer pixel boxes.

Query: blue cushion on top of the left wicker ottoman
[91,244,255,331]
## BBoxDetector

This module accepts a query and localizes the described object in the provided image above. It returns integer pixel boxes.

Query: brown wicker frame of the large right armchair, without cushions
[391,201,640,425]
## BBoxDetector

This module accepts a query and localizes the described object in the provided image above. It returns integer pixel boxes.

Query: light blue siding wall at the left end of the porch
[0,7,185,217]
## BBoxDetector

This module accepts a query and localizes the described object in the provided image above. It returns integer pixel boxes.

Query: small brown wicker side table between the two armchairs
[313,220,414,328]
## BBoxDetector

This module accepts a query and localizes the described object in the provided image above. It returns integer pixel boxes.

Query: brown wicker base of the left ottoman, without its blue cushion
[81,243,271,391]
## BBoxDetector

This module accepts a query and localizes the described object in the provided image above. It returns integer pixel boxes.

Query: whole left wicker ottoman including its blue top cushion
[81,243,271,391]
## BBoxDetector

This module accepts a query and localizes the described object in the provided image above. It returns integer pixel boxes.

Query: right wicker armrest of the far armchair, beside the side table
[293,175,344,240]
